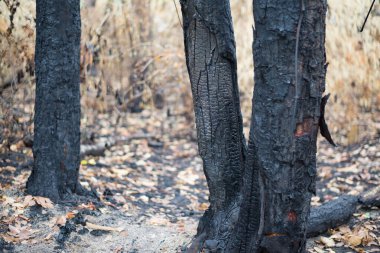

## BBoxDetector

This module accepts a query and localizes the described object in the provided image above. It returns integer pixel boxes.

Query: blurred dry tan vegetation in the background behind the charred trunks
[0,0,380,151]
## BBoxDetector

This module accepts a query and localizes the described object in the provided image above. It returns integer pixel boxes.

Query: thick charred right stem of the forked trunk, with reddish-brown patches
[236,0,327,252]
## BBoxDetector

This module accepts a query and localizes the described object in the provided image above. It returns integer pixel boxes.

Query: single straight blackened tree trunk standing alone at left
[27,0,81,201]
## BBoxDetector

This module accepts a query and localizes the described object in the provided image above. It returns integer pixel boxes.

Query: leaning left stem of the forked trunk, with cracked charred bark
[181,0,246,248]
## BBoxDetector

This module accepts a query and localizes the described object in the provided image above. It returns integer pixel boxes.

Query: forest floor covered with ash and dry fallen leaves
[0,111,380,253]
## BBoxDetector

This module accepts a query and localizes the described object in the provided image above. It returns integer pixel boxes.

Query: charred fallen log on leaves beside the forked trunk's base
[307,186,380,238]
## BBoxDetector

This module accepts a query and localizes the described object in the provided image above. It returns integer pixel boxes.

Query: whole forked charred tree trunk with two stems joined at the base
[181,0,327,252]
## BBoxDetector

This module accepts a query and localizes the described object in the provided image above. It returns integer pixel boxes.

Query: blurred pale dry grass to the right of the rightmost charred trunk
[326,0,380,144]
